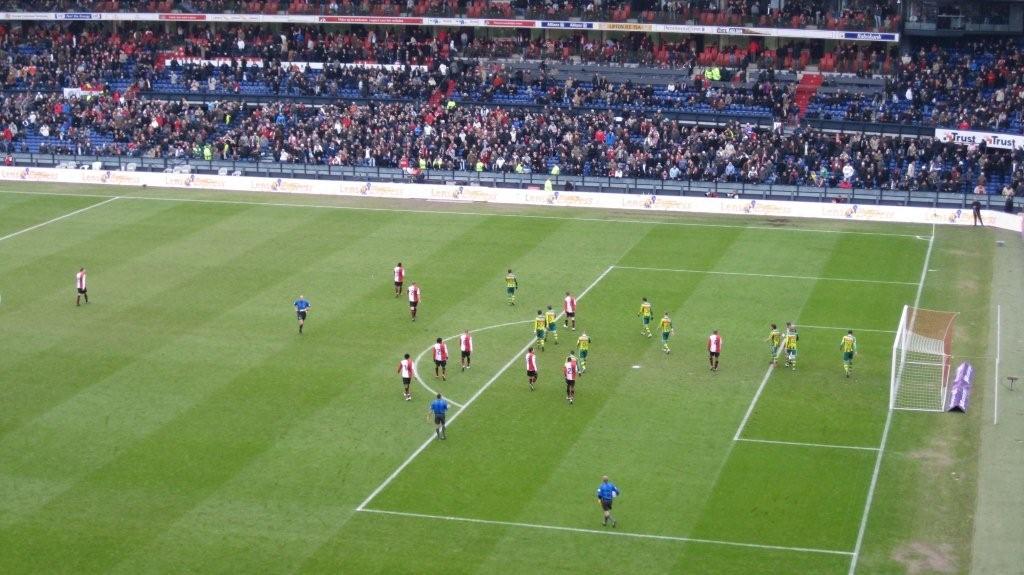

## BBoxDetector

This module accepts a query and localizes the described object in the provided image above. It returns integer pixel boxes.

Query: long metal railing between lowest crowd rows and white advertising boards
[11,153,1005,210]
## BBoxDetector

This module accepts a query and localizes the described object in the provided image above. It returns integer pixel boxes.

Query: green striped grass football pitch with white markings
[0,184,1007,574]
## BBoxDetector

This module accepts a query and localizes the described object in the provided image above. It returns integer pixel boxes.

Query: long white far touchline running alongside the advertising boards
[0,189,916,237]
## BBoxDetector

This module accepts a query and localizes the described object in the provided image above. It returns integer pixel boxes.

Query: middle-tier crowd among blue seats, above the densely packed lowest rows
[6,25,1024,133]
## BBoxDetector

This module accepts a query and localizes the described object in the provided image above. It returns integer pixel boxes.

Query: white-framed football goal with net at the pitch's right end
[889,306,956,411]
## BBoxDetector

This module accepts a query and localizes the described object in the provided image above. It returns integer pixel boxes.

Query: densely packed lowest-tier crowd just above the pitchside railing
[0,89,1024,192]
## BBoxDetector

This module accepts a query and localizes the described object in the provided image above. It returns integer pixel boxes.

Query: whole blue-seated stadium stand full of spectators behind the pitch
[0,0,1024,199]
